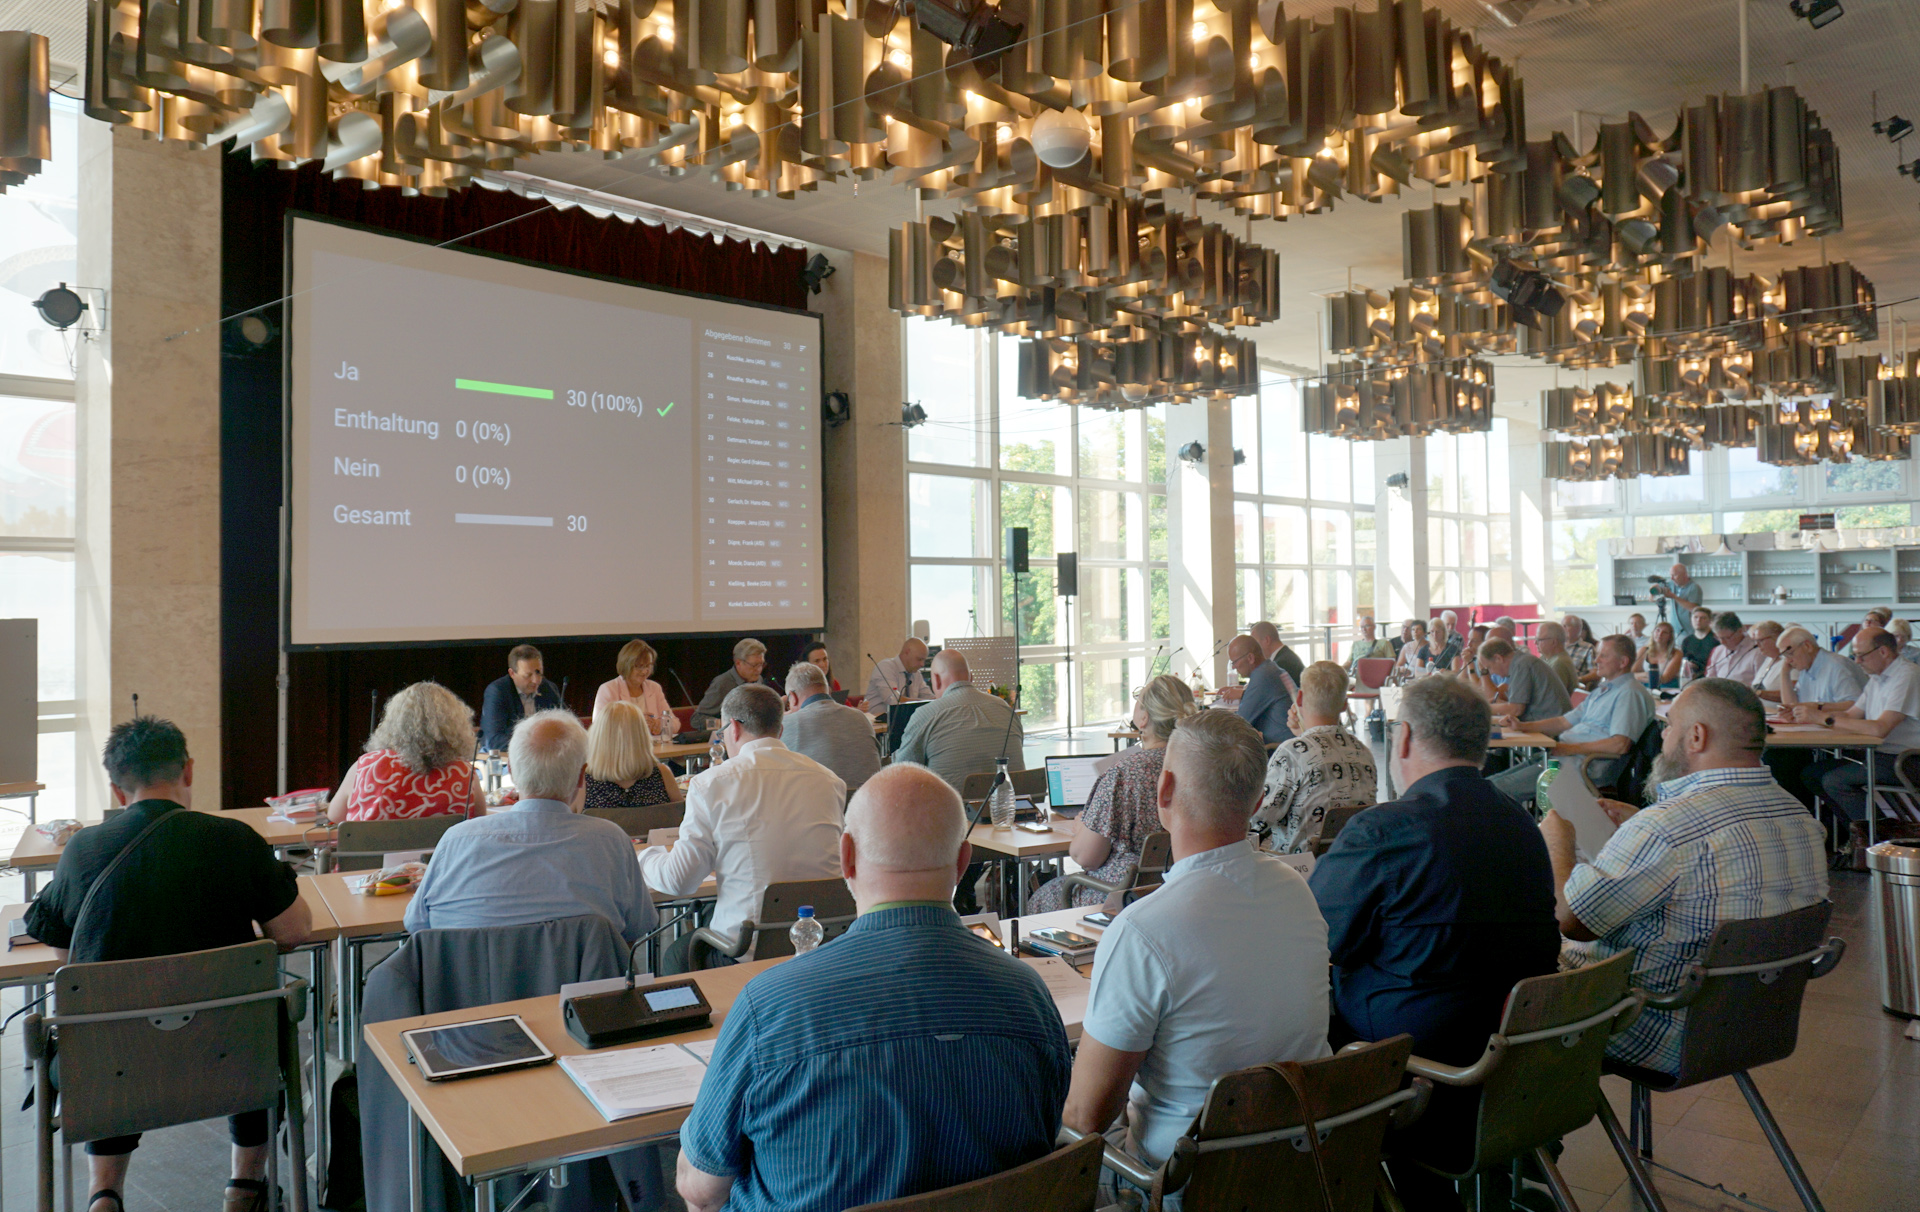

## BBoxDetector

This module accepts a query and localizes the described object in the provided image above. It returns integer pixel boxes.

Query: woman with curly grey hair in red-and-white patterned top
[326,682,486,824]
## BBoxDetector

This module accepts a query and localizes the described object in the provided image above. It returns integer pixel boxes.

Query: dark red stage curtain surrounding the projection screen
[221,156,817,807]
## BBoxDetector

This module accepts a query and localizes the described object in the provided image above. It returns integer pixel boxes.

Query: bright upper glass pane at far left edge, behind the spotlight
[0,96,78,382]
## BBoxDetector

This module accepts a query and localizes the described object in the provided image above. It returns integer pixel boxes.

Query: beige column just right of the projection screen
[812,250,908,693]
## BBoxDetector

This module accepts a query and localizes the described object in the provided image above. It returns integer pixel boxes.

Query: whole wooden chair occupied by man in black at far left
[25,939,307,1212]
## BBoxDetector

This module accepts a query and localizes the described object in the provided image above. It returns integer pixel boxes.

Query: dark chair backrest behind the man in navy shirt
[1463,951,1634,1174]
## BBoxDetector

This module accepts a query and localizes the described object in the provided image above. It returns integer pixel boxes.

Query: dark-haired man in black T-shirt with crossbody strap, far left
[27,715,313,1212]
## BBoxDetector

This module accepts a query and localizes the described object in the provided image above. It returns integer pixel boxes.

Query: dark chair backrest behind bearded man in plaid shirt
[1674,901,1834,1085]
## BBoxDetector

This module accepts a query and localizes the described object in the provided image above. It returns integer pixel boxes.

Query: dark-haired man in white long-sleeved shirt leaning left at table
[639,684,847,974]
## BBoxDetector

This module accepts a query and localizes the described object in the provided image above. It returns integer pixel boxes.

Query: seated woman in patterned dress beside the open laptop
[1027,674,1198,912]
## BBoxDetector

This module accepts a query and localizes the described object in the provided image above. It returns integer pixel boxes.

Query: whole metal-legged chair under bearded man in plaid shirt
[1607,901,1847,1212]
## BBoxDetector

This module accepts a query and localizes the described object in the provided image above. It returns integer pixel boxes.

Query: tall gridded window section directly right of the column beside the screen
[902,321,1171,732]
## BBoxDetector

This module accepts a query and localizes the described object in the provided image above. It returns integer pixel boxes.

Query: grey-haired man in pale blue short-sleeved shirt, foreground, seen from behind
[1062,714,1327,1166]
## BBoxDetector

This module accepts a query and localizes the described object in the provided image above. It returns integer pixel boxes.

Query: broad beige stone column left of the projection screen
[75,119,222,816]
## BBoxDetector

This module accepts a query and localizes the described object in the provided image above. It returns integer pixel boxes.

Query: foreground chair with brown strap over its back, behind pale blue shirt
[1060,1035,1432,1212]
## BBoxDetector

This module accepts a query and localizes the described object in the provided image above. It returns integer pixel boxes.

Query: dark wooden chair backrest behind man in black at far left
[54,939,288,1141]
